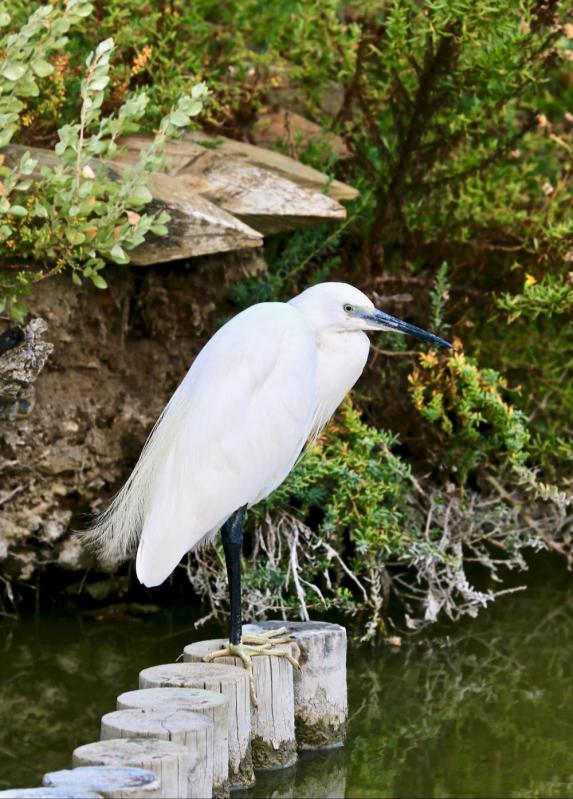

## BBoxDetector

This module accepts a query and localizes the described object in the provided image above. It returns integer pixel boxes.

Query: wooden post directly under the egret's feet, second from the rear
[184,638,296,769]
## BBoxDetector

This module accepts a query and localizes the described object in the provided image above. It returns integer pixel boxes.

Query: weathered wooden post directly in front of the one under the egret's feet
[139,663,251,788]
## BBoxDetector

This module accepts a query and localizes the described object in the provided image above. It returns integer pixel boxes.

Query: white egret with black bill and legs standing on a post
[86,283,451,700]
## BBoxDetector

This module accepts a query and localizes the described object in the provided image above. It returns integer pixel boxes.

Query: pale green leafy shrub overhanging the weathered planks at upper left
[0,2,207,321]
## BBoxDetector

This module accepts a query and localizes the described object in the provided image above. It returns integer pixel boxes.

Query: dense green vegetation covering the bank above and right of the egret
[0,0,573,636]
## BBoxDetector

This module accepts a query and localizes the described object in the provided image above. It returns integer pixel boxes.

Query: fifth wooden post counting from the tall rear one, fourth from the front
[101,710,213,799]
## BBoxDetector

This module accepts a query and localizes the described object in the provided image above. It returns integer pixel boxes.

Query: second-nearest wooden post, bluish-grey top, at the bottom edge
[44,766,160,799]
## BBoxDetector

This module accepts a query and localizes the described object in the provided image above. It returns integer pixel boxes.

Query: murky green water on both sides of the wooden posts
[0,572,573,799]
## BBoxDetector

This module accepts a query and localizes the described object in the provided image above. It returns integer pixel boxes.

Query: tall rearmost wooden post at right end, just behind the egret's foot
[243,621,348,749]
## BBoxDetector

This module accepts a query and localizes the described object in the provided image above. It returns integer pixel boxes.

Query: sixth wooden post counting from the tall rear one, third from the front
[72,738,189,799]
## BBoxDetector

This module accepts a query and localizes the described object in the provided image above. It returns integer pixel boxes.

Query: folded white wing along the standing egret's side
[133,303,317,585]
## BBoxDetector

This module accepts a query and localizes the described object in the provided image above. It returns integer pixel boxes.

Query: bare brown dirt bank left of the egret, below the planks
[0,251,264,593]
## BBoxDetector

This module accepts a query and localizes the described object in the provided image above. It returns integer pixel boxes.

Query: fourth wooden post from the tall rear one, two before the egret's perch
[117,688,229,799]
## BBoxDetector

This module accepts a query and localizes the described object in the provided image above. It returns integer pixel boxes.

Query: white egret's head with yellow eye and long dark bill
[291,283,452,348]
